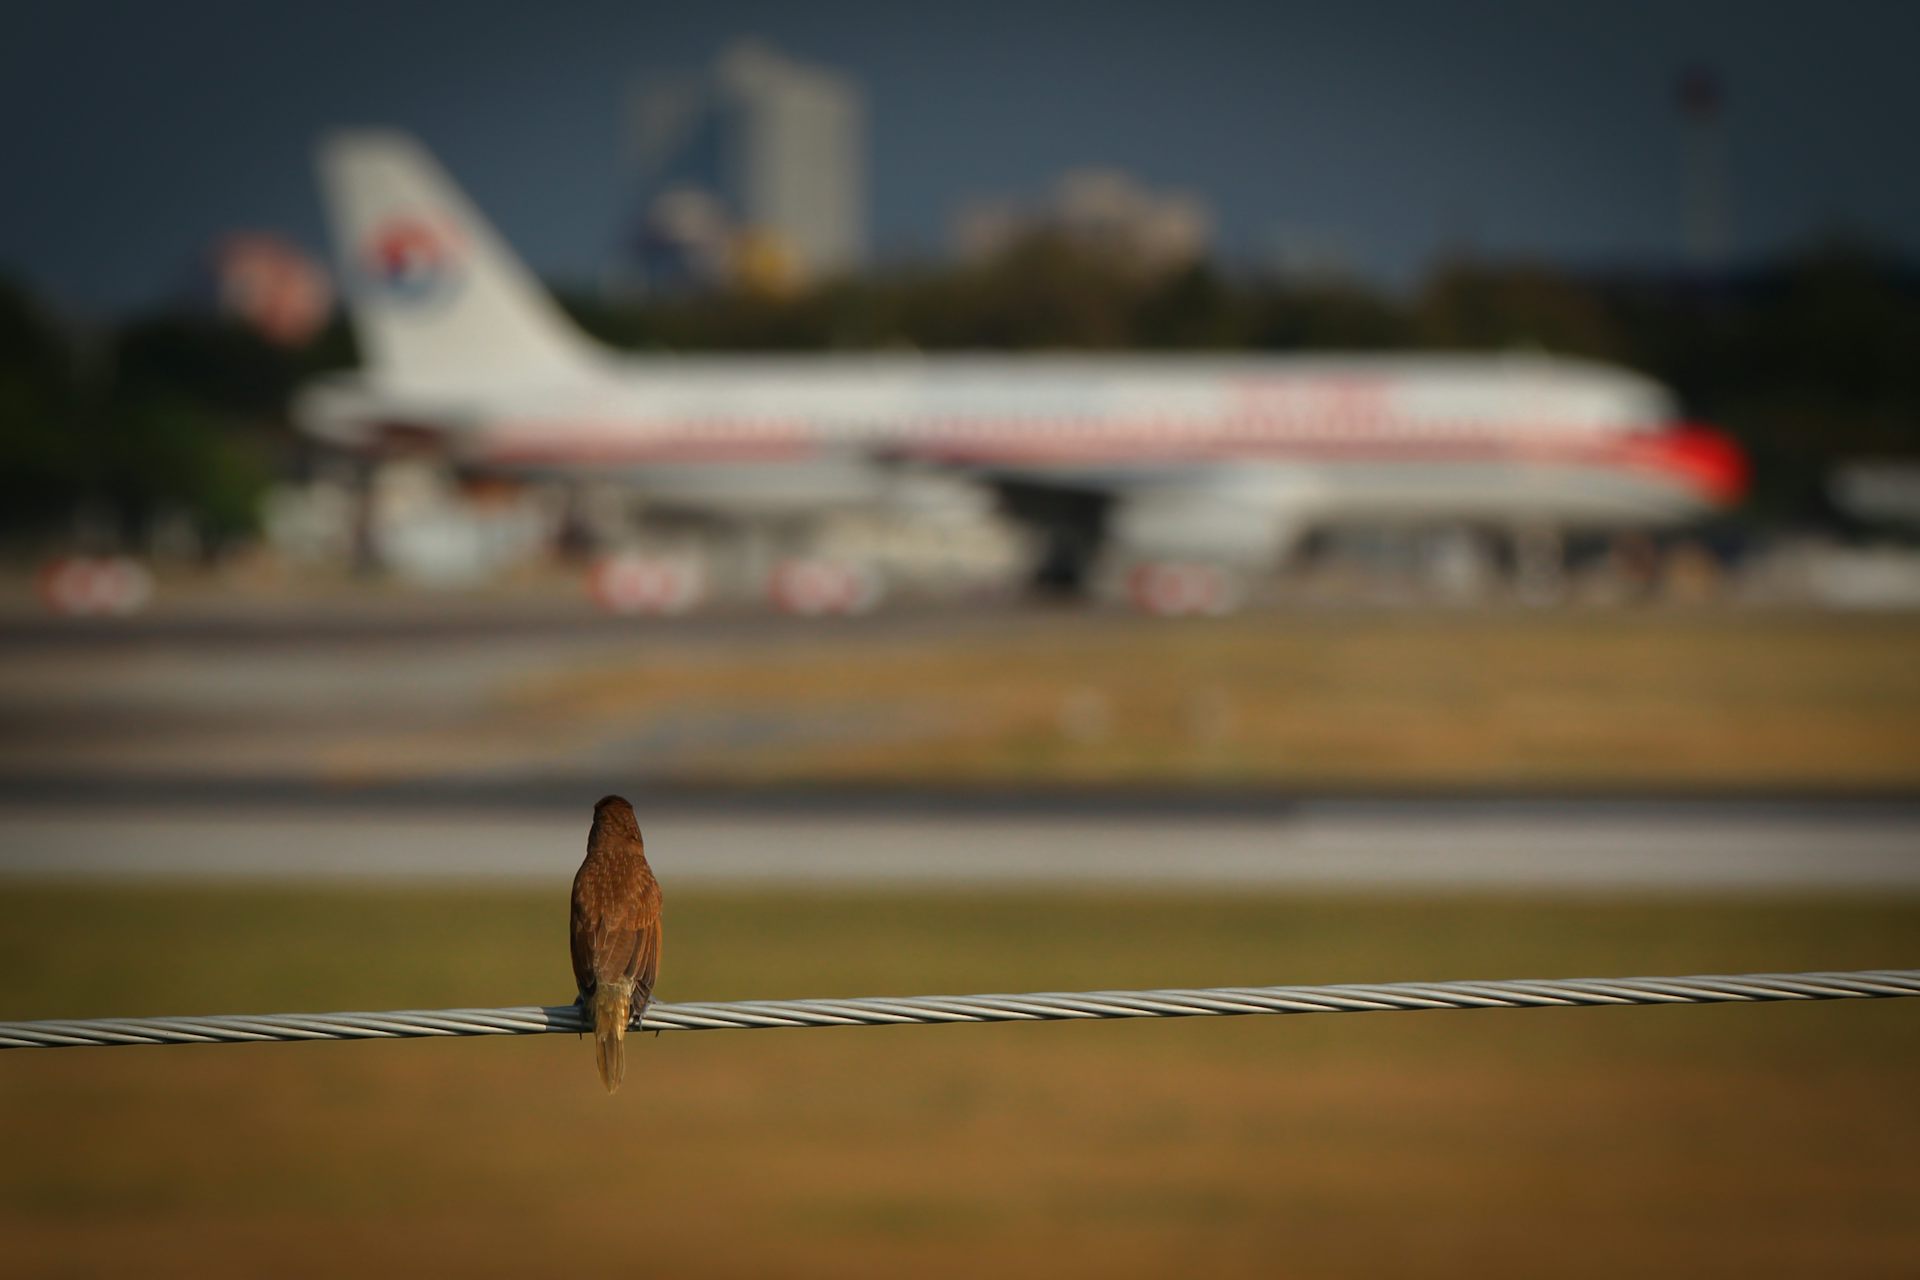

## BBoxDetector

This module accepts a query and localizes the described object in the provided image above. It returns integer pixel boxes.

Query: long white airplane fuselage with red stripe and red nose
[303,355,1741,524]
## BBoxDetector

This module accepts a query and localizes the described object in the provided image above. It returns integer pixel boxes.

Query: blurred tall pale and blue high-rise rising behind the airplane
[632,40,868,288]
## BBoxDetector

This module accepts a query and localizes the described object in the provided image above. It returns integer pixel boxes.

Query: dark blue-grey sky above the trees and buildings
[0,0,1920,311]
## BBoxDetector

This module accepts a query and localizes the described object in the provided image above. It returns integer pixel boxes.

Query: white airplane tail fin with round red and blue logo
[319,130,597,388]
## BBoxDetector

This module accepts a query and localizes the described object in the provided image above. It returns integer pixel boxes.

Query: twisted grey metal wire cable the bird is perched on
[0,969,1920,1050]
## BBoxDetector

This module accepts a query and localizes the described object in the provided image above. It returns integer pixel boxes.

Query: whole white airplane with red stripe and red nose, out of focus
[296,130,1747,614]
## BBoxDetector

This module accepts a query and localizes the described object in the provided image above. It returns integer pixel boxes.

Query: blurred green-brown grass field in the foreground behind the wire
[0,883,1920,1276]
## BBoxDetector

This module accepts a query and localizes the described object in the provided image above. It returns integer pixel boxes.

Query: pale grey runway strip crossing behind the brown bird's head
[0,796,1920,892]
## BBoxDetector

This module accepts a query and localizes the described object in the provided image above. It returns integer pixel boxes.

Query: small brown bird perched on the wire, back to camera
[570,796,660,1094]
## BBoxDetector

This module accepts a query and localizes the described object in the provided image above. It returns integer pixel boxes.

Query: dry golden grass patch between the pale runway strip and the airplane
[491,610,1920,787]
